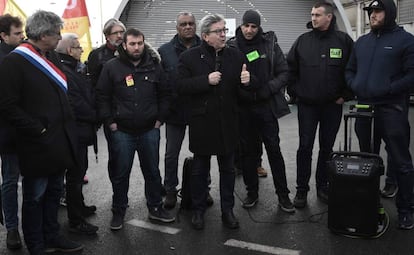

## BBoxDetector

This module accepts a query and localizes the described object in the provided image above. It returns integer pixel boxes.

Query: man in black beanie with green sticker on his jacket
[228,10,295,213]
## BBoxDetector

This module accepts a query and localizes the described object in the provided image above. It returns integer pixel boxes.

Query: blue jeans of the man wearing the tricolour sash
[22,173,63,254]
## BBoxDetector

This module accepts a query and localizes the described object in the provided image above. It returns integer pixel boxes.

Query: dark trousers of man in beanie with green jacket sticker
[239,105,289,197]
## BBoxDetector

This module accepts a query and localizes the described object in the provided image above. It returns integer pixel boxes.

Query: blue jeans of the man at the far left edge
[1,153,20,231]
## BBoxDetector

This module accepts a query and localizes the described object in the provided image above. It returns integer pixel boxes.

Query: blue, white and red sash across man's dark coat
[13,43,68,93]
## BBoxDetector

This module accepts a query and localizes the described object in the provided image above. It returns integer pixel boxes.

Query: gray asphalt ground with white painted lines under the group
[0,102,414,255]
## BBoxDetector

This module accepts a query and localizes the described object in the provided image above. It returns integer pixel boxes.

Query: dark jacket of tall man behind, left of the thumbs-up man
[158,35,201,125]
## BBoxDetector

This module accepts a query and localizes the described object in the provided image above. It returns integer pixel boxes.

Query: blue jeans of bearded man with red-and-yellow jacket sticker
[109,128,162,212]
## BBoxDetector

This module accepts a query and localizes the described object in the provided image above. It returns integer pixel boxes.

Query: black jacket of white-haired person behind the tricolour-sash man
[59,54,98,145]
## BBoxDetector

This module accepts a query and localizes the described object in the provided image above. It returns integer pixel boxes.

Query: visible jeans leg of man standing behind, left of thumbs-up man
[164,123,186,192]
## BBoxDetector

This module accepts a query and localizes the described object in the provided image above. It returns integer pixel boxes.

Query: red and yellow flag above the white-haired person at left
[62,0,92,61]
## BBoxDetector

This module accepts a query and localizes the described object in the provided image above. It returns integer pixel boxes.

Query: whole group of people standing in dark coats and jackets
[0,0,414,254]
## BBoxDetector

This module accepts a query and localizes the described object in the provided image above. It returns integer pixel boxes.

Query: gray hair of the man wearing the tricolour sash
[26,10,63,41]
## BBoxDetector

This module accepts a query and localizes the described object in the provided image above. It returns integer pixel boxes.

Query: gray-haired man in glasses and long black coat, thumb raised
[177,14,250,229]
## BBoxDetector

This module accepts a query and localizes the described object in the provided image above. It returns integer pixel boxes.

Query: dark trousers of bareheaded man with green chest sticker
[296,102,342,192]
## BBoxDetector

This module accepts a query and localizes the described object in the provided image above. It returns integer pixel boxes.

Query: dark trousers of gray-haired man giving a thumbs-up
[190,153,235,213]
